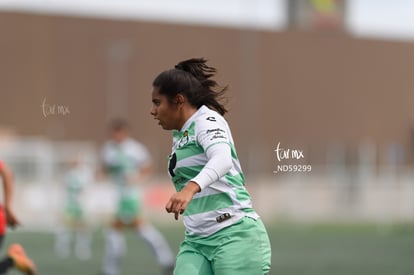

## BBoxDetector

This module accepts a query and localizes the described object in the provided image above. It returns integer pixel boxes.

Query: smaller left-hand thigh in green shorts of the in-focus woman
[174,241,214,275]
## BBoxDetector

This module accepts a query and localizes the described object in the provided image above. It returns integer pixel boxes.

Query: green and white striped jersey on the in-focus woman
[168,106,258,236]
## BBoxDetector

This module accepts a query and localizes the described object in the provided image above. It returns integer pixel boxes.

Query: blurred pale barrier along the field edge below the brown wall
[0,138,414,230]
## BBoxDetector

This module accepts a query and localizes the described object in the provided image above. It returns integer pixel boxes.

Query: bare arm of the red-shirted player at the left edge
[0,161,19,227]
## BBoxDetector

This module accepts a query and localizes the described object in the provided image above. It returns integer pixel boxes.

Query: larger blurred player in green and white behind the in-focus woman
[102,119,174,275]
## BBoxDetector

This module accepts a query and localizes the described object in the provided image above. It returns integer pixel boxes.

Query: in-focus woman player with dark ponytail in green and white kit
[151,59,271,275]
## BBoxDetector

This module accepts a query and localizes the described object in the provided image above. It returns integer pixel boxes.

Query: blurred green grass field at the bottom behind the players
[2,224,414,275]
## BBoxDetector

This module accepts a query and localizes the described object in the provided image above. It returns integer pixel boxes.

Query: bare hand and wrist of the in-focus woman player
[165,181,200,220]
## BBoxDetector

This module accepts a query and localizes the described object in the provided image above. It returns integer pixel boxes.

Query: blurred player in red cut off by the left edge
[0,160,35,275]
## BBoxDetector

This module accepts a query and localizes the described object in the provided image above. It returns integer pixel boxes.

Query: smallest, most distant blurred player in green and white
[55,159,91,260]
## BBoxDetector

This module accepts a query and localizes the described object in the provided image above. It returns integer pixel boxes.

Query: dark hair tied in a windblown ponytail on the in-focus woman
[152,58,227,115]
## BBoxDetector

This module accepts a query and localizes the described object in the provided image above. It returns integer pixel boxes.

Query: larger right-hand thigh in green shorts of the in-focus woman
[213,218,271,275]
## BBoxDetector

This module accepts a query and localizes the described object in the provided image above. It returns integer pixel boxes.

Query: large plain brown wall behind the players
[0,13,414,174]
